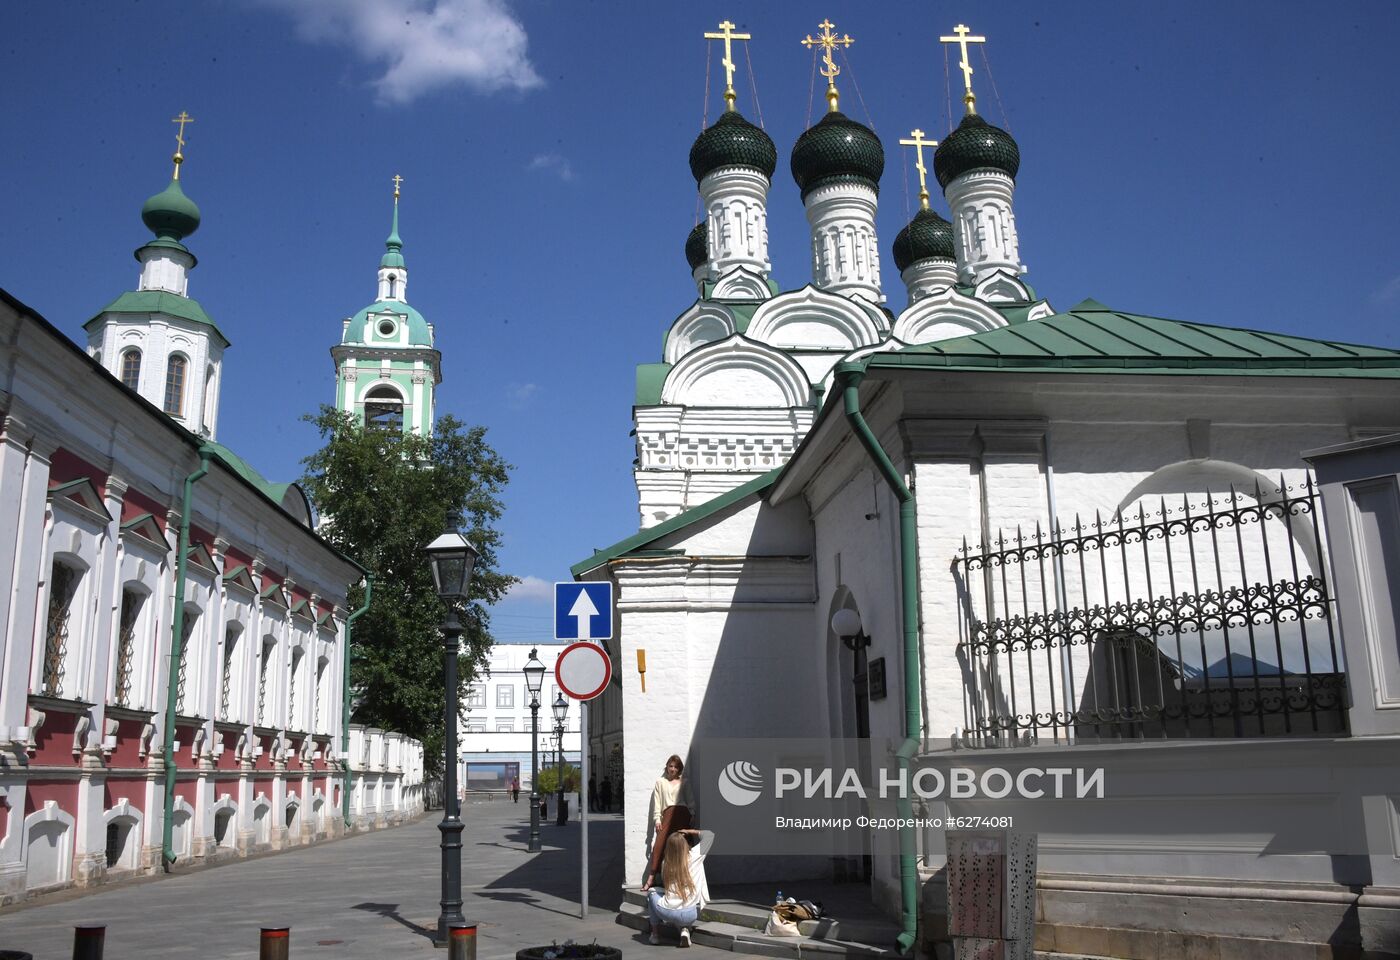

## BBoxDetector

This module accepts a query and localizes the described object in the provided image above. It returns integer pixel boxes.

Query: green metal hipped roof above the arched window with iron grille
[869,299,1400,378]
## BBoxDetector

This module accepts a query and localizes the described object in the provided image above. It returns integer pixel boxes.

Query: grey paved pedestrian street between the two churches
[0,799,711,960]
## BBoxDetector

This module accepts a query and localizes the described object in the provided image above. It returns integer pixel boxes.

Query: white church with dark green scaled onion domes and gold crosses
[573,22,1400,957]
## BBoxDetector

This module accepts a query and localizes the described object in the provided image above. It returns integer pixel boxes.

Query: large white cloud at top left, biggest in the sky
[263,0,545,104]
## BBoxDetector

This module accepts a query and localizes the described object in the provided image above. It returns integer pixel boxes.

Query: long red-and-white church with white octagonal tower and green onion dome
[0,154,423,904]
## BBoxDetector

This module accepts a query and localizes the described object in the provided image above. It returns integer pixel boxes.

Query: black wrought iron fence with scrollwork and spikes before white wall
[953,479,1347,743]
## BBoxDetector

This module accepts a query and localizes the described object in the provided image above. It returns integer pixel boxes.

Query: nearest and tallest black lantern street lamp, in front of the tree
[424,516,480,943]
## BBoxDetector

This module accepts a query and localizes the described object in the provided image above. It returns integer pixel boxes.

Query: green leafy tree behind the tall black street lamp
[302,407,517,771]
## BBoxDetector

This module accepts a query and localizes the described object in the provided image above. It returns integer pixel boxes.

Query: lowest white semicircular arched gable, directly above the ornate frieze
[661,334,812,407]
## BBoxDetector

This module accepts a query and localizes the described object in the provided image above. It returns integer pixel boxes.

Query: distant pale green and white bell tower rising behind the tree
[330,178,442,437]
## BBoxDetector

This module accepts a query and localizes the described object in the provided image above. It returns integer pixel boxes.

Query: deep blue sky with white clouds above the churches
[0,0,1400,641]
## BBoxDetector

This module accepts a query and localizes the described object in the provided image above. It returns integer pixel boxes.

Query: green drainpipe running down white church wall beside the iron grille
[836,362,920,953]
